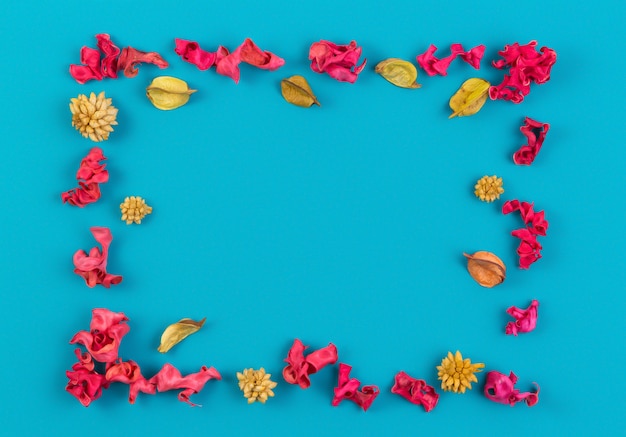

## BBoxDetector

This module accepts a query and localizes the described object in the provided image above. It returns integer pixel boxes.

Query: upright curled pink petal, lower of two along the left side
[73,226,122,288]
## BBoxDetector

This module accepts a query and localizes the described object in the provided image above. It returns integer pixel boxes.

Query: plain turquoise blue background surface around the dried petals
[0,0,626,436]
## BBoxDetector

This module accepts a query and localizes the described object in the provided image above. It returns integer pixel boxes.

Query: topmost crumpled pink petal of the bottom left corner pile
[70,308,130,363]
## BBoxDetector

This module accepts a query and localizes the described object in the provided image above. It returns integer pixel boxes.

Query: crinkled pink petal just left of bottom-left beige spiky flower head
[148,363,222,407]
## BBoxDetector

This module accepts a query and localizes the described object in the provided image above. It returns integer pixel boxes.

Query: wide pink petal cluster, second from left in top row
[174,38,285,83]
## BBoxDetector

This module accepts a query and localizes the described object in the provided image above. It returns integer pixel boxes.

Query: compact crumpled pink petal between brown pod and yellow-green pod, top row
[309,40,367,83]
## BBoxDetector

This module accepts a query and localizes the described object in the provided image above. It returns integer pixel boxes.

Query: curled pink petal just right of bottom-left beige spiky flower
[283,338,337,389]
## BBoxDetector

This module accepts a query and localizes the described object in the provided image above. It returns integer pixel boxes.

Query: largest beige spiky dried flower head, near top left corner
[70,91,117,142]
